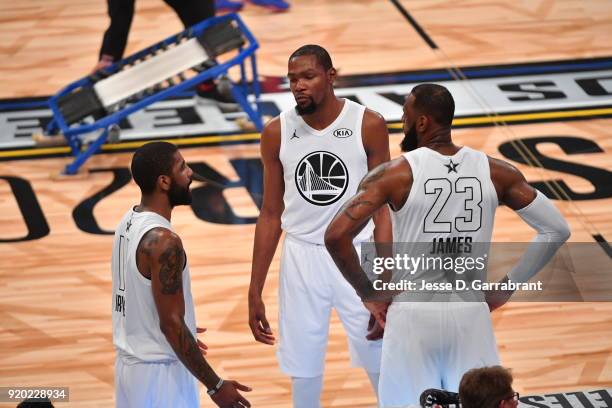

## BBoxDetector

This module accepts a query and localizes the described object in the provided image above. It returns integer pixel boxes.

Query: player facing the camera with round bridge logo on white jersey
[249,45,392,408]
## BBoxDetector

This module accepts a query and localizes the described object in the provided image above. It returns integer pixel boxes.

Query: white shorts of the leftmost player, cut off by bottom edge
[115,356,200,408]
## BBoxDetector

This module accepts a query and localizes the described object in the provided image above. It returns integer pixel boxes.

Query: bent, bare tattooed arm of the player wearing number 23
[325,157,412,299]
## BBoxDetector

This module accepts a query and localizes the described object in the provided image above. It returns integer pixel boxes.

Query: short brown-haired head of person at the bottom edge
[459,366,518,408]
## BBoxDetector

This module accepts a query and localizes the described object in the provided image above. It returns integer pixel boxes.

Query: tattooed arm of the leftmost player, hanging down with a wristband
[137,228,250,407]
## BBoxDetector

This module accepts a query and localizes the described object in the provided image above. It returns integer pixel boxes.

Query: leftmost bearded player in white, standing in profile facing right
[112,142,250,408]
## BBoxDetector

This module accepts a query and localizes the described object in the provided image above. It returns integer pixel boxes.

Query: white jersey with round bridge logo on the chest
[280,99,374,245]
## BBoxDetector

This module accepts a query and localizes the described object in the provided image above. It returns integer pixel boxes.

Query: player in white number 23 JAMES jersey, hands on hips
[325,84,569,407]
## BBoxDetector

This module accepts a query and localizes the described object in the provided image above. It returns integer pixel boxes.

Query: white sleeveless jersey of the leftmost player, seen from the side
[111,209,196,362]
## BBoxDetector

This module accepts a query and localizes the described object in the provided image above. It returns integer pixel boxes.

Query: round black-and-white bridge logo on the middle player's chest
[295,151,349,205]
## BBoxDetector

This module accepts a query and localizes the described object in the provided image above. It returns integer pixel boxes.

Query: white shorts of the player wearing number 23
[378,302,499,408]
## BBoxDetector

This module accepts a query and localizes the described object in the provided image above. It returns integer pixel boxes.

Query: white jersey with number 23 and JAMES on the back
[391,147,497,301]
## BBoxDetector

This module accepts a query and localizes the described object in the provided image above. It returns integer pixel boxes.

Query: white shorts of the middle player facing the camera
[276,235,382,378]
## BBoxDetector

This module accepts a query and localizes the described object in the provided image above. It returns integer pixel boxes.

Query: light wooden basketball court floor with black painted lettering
[0,0,612,408]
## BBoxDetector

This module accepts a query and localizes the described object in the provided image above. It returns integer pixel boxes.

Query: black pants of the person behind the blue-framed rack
[98,0,215,61]
